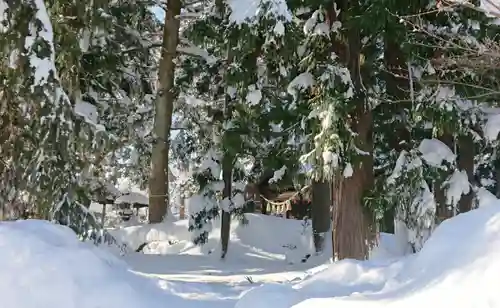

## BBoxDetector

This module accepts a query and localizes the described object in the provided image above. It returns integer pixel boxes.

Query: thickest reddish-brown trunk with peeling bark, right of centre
[333,0,375,260]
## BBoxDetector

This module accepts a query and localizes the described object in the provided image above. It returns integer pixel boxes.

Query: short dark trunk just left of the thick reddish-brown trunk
[311,181,332,253]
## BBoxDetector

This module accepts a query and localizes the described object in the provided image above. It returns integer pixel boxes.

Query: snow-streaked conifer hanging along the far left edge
[0,1,86,227]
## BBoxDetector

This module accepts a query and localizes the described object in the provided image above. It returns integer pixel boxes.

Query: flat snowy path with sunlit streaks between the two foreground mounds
[124,254,316,308]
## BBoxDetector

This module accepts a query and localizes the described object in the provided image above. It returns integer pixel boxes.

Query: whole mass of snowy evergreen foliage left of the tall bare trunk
[0,1,157,235]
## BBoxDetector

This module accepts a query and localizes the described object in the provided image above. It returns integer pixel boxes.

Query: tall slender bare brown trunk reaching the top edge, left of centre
[149,0,181,223]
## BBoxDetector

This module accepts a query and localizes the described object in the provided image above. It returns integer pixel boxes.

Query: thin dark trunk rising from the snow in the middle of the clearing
[220,153,233,259]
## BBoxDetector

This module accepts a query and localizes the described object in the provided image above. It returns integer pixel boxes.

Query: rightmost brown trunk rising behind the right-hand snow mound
[458,134,475,213]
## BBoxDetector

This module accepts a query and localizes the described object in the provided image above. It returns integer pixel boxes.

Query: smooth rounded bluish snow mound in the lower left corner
[0,220,184,308]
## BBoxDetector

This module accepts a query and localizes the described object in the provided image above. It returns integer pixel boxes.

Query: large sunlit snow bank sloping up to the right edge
[236,200,500,308]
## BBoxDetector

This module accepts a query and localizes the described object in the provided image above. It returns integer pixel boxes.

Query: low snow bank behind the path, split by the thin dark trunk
[110,214,316,262]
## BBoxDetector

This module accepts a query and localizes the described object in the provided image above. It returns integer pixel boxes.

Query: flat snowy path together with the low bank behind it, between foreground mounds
[109,215,329,308]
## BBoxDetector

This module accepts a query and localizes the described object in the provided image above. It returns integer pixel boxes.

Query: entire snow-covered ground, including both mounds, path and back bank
[0,201,500,308]
